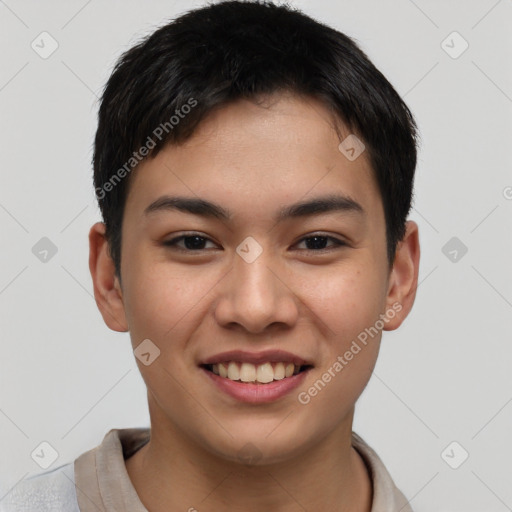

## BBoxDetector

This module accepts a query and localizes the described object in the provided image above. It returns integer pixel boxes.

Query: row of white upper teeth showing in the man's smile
[212,361,300,384]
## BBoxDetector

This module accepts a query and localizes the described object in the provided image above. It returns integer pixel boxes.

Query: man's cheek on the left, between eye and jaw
[121,258,209,400]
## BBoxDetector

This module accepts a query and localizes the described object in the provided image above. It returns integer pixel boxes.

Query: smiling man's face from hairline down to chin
[90,95,418,461]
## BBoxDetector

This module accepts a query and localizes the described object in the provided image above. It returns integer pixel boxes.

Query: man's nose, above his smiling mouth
[215,246,299,334]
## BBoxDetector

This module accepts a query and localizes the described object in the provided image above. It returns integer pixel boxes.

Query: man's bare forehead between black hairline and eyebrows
[123,94,380,225]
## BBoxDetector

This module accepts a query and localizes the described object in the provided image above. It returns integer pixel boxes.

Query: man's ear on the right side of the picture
[384,221,420,331]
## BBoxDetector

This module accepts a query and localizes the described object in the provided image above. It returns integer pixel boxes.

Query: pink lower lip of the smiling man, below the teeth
[201,368,309,404]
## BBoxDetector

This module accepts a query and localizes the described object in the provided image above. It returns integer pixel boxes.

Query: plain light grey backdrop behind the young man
[0,0,512,512]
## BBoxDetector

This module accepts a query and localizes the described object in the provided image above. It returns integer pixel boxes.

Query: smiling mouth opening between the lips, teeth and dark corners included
[200,360,313,385]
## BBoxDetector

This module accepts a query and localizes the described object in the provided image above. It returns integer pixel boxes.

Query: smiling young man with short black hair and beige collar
[3,1,419,512]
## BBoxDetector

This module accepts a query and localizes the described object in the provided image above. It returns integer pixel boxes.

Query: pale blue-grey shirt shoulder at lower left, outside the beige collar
[0,462,80,512]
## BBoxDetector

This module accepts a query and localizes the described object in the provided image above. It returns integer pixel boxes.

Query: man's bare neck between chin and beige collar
[126,400,372,512]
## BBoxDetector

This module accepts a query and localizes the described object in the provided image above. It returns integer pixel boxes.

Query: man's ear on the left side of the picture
[89,222,128,332]
